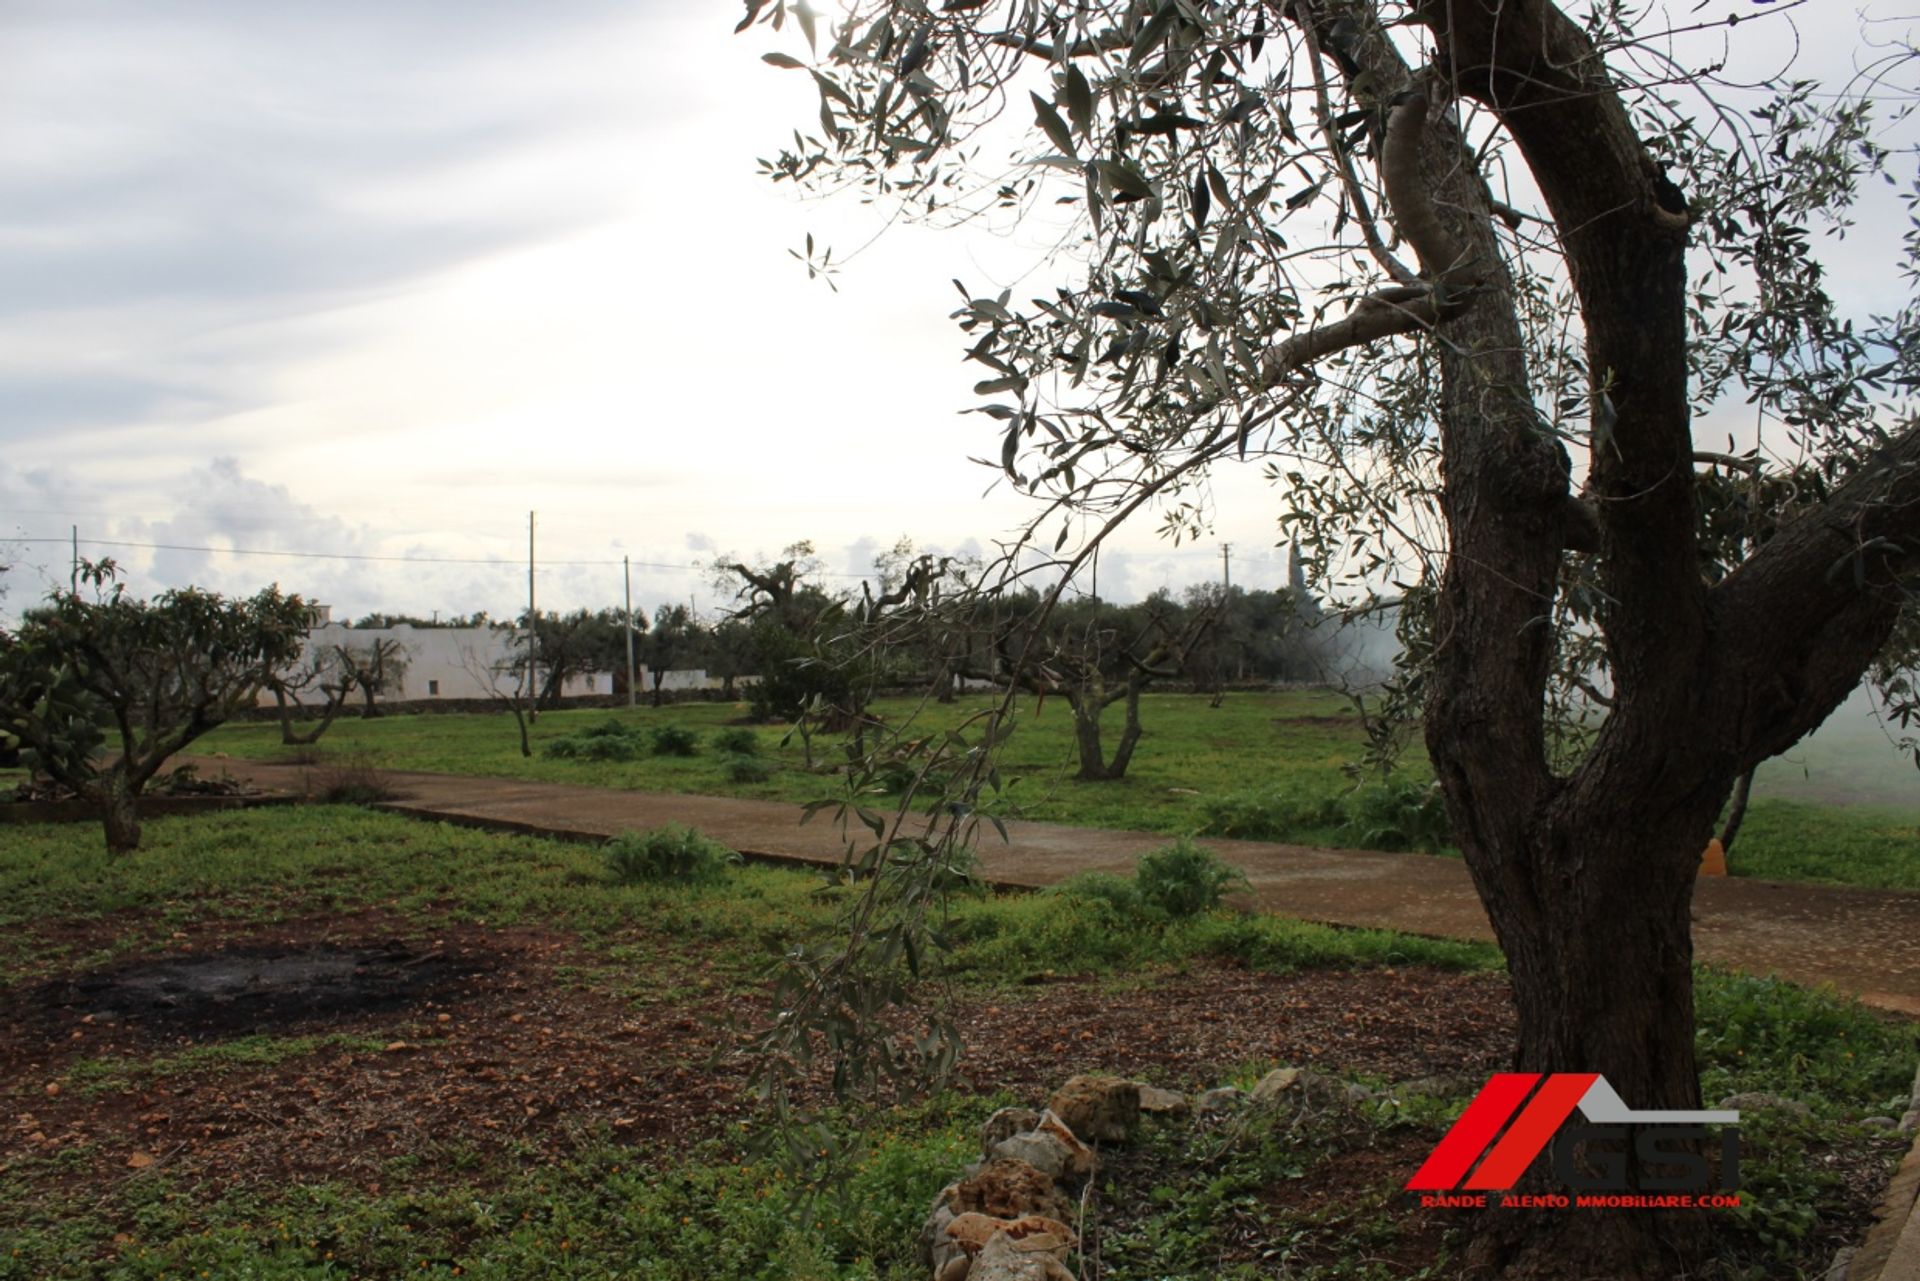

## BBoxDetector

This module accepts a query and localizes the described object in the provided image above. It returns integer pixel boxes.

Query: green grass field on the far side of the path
[198,691,1920,889]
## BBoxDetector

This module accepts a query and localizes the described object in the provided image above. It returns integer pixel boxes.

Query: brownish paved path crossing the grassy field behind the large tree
[183,759,1920,1018]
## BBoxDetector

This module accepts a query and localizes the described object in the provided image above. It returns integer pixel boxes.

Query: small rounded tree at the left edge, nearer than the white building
[0,561,309,851]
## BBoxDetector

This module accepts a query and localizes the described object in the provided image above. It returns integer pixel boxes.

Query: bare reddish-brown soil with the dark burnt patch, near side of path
[0,912,1511,1221]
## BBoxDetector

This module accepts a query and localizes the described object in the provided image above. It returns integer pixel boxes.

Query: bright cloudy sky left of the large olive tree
[0,0,1912,615]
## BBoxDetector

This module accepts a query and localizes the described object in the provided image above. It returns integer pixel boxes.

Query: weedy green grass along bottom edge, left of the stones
[0,1097,995,1281]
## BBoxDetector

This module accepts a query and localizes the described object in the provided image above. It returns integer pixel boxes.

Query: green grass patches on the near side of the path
[0,805,1916,1281]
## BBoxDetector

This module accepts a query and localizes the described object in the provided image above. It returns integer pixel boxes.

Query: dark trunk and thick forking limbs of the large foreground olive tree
[1336,0,1920,1279]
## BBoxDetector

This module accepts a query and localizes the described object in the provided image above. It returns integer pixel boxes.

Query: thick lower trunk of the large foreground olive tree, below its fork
[1461,756,1732,1281]
